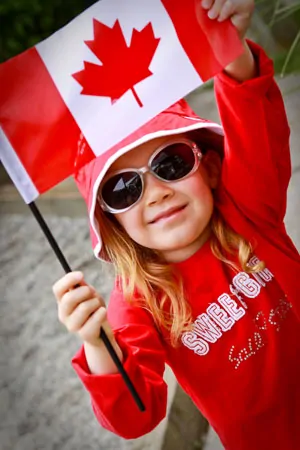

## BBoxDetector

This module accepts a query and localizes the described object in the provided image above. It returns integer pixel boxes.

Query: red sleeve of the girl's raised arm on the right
[215,41,291,226]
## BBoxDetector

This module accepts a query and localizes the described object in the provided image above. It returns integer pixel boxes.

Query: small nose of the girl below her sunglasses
[144,172,174,206]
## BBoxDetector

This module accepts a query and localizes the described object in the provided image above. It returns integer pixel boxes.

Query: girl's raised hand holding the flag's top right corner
[199,0,255,39]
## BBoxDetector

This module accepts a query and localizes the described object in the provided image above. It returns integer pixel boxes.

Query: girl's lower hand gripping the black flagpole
[53,272,114,347]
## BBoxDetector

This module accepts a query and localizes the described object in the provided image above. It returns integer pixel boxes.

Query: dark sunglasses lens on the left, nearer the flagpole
[101,171,142,210]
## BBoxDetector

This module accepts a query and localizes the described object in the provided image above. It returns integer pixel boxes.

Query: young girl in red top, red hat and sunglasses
[53,0,300,450]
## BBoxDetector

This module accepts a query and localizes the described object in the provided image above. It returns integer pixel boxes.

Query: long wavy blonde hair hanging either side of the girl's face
[97,209,265,347]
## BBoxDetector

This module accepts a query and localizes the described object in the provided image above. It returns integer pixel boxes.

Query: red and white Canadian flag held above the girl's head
[0,0,241,203]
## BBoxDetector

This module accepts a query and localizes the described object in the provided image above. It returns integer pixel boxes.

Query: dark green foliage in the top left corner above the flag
[0,0,94,62]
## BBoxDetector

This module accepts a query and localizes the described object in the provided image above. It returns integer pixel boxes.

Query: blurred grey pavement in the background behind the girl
[0,74,300,450]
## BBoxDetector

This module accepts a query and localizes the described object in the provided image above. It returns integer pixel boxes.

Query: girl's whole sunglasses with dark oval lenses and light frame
[98,139,202,214]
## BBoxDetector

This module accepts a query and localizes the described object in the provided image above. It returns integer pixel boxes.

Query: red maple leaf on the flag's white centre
[72,19,160,106]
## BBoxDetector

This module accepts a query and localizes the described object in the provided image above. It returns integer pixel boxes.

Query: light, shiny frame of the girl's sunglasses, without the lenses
[98,138,203,214]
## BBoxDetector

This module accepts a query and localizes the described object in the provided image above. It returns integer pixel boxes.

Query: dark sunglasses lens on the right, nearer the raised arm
[151,143,195,181]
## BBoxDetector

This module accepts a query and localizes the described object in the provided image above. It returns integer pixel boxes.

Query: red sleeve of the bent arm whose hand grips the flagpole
[72,289,167,439]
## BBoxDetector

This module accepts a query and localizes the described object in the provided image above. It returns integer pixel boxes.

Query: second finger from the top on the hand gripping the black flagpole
[58,285,96,321]
